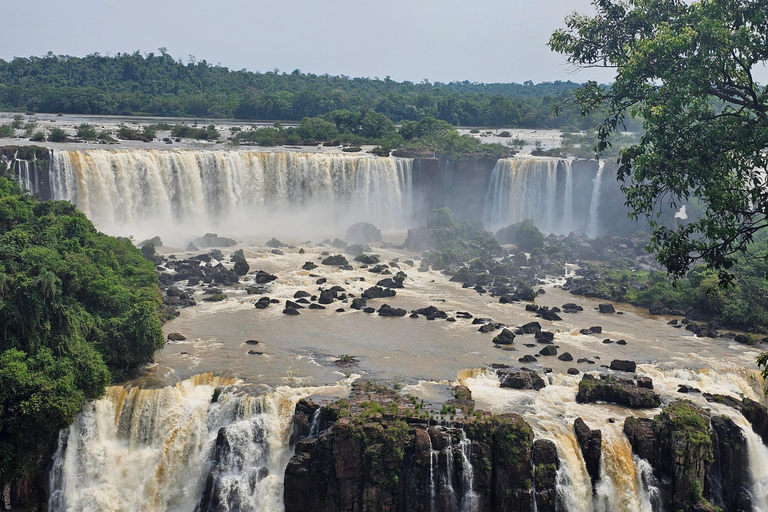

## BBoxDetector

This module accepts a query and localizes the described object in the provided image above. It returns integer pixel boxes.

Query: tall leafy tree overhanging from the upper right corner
[549,0,768,283]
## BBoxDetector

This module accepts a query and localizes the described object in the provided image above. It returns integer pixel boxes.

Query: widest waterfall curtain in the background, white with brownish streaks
[45,149,412,241]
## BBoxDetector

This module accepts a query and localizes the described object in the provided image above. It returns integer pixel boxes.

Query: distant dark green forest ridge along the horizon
[0,52,593,128]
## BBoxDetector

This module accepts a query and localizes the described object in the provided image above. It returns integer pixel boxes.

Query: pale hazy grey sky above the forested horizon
[0,0,612,82]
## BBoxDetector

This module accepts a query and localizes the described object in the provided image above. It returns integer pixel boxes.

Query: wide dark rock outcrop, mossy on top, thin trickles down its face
[284,382,558,512]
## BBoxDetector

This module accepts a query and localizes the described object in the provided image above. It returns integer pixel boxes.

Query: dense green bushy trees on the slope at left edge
[0,163,163,483]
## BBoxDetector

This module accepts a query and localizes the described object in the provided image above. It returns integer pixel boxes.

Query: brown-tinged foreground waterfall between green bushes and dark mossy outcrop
[48,374,351,512]
